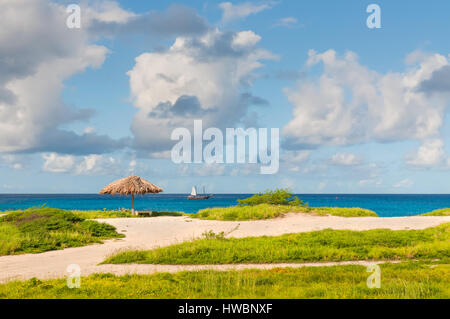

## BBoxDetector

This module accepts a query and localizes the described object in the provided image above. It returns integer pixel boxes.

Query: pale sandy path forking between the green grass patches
[0,214,450,282]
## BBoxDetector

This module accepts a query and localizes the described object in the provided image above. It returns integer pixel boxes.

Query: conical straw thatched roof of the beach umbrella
[100,175,163,195]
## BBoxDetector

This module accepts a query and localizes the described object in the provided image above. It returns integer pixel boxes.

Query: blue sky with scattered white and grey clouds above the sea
[0,0,450,193]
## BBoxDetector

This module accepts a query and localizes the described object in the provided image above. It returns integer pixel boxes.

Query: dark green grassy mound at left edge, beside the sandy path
[0,208,124,256]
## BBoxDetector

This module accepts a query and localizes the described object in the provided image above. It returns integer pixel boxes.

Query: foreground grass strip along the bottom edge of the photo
[0,262,450,299]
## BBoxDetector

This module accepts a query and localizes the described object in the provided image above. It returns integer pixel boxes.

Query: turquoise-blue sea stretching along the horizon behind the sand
[0,194,450,217]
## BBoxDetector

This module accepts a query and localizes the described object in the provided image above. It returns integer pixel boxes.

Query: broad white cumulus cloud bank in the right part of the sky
[283,50,449,149]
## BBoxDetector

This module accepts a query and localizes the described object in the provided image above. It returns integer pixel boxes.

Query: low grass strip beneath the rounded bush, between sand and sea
[189,204,378,221]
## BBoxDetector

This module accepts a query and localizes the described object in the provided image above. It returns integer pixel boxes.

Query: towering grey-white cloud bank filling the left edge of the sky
[0,0,129,153]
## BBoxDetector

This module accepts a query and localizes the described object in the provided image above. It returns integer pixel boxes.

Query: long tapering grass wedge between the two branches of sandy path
[103,223,450,265]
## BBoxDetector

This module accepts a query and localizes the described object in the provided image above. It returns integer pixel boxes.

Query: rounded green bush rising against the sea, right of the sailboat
[238,189,308,207]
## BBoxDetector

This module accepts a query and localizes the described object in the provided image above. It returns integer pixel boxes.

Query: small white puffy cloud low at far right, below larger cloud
[406,139,445,166]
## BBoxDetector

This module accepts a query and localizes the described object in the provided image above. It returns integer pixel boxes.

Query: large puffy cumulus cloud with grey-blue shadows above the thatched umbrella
[128,30,274,153]
